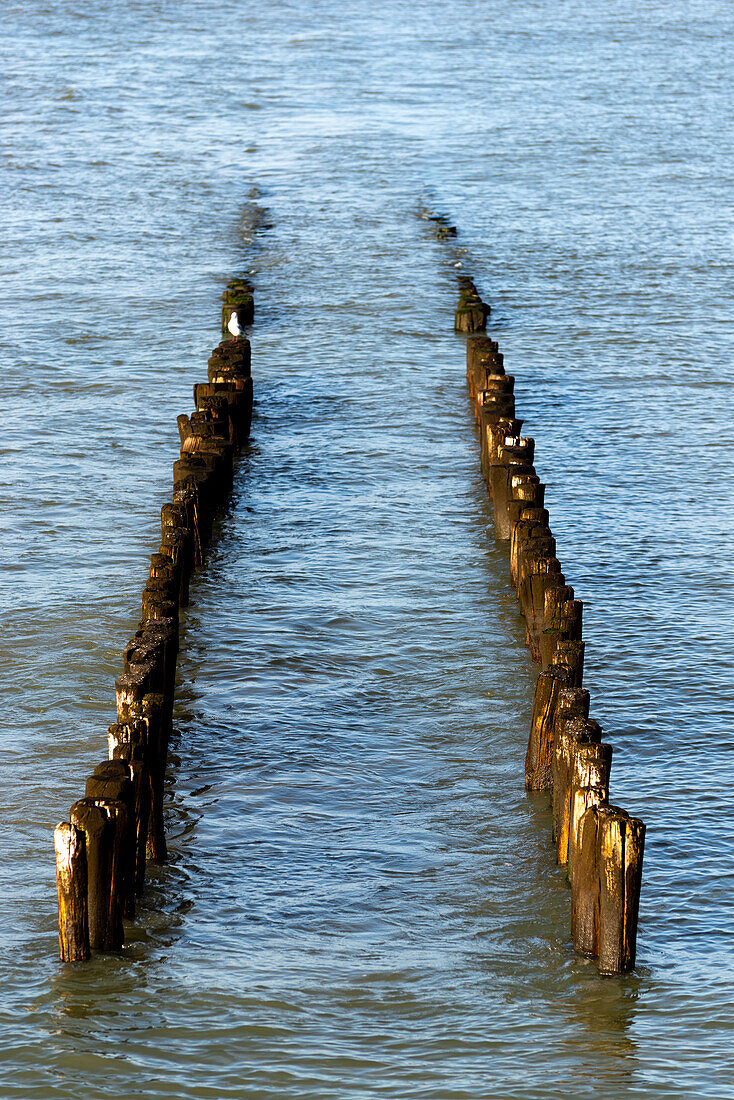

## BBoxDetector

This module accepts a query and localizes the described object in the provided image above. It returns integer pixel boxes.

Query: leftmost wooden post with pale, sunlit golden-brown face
[54,822,89,963]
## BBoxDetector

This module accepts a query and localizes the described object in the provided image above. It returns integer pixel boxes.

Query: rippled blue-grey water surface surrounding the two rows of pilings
[0,0,734,1100]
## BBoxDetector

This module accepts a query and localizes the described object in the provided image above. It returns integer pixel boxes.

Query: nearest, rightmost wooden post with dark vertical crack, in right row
[596,806,645,975]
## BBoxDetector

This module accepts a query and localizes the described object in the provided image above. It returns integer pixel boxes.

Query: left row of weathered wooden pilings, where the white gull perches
[54,279,253,961]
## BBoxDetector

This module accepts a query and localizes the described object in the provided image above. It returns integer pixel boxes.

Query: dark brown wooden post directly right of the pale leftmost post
[70,799,122,952]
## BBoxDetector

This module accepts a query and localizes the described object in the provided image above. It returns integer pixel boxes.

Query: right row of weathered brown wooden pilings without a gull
[454,277,645,975]
